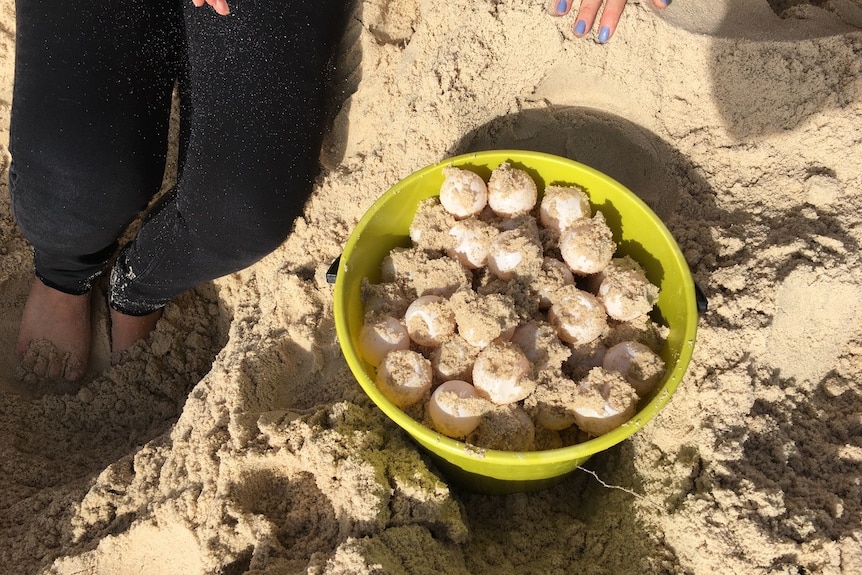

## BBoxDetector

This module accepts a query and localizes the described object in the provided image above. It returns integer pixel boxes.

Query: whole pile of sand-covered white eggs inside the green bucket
[358,163,665,451]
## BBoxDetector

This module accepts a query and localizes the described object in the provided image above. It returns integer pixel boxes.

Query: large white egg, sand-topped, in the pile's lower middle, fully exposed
[473,343,536,405]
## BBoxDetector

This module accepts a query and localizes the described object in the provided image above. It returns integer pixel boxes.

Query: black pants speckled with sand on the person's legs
[10,0,345,315]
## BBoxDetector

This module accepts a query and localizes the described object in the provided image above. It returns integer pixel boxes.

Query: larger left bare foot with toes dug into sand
[15,279,90,381]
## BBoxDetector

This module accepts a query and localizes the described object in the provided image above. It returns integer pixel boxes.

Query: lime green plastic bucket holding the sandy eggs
[334,150,697,493]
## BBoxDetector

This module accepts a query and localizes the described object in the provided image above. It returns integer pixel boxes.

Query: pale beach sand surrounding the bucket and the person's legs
[0,0,862,575]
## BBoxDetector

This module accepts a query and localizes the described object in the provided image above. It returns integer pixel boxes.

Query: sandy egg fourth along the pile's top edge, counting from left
[560,212,617,275]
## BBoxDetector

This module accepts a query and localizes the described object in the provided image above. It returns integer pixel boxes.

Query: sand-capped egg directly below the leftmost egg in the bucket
[376,349,432,408]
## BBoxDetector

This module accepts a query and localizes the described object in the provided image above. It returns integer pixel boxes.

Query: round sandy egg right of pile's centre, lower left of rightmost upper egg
[548,286,608,345]
